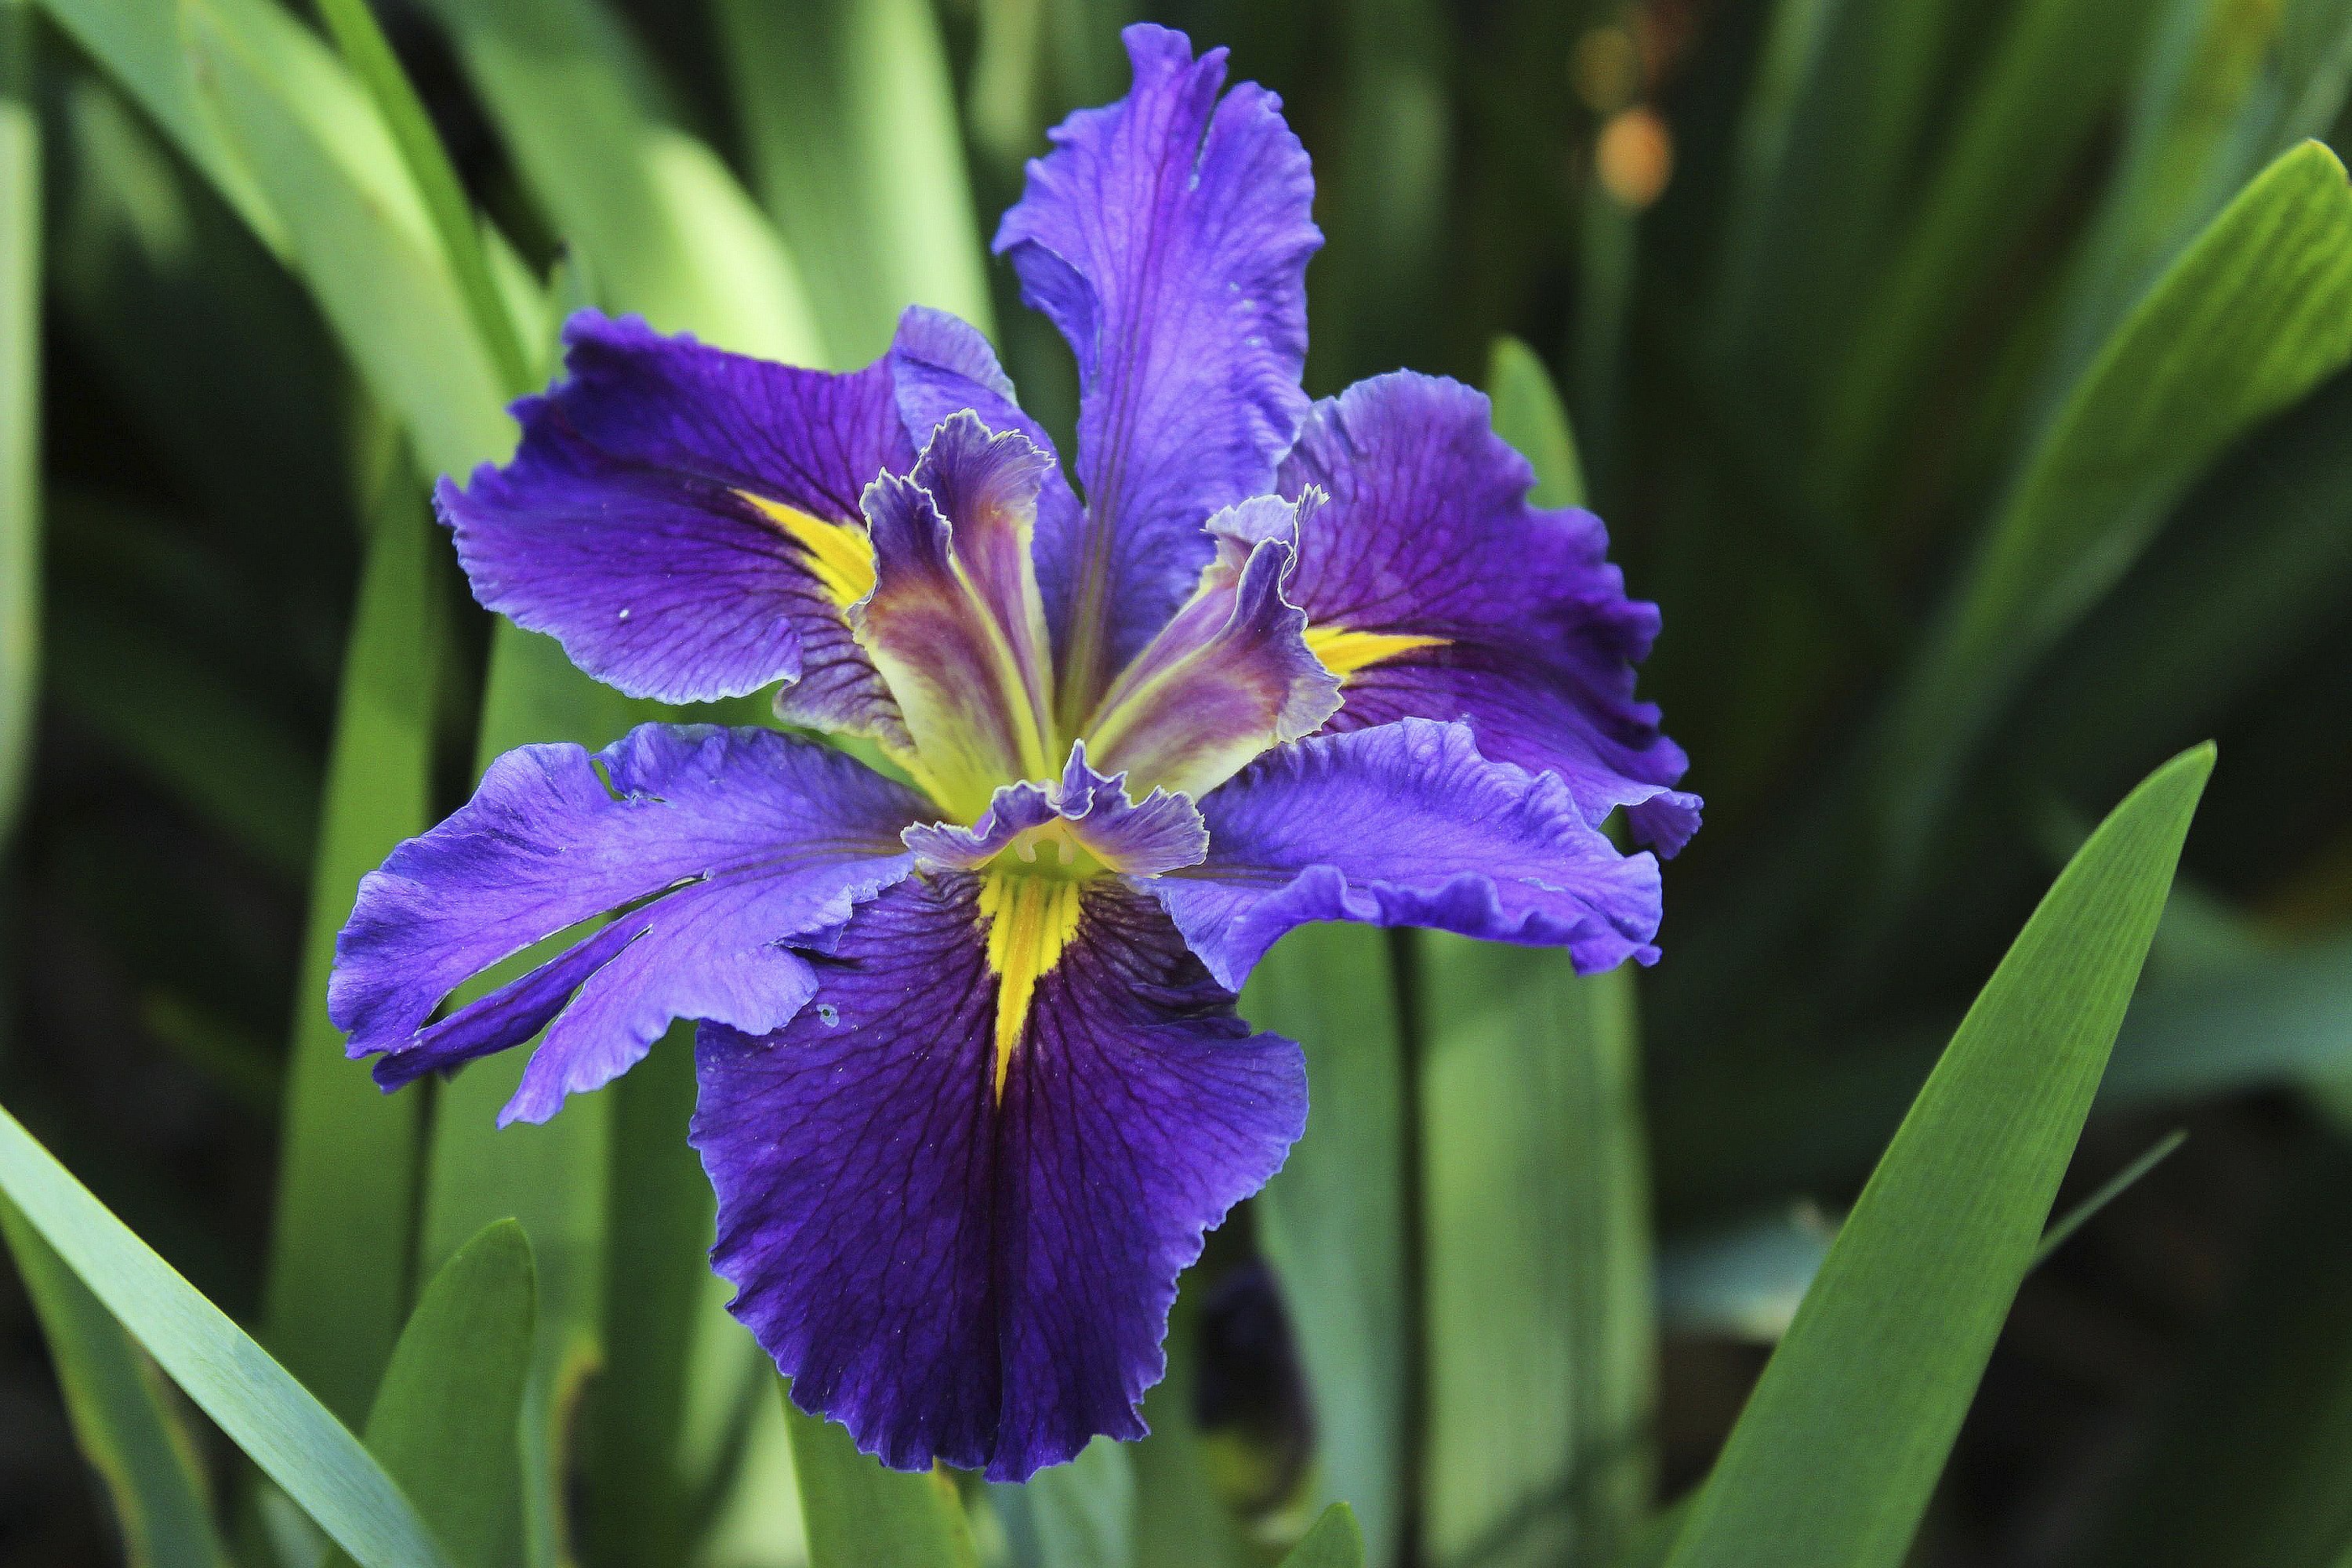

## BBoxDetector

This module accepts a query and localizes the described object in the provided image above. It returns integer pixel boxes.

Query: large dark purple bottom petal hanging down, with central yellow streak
[694,874,1305,1481]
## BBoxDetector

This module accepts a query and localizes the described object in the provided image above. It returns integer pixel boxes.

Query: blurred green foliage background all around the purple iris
[0,0,2352,1568]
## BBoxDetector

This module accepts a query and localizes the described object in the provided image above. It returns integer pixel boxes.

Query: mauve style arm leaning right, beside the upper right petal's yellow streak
[1087,496,1341,794]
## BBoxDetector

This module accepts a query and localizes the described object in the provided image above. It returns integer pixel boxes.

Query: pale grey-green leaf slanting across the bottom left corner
[0,1109,454,1568]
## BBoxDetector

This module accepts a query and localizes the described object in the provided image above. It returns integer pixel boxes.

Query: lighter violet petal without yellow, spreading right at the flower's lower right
[1148,720,1658,989]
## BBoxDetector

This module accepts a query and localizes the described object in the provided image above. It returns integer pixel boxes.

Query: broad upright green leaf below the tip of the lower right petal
[1416,935,1656,1563]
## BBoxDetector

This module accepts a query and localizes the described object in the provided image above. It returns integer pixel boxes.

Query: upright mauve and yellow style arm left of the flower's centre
[849,414,1051,813]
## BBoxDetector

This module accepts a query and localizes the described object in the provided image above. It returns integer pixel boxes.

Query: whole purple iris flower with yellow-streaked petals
[329,26,1698,1481]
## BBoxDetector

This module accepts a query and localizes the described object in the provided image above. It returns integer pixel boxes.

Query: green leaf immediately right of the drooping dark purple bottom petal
[1242,924,1416,1563]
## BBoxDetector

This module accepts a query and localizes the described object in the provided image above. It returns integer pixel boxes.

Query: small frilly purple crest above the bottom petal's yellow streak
[901,746,1209,877]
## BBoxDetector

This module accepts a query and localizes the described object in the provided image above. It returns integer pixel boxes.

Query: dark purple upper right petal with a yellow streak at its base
[1282,372,1698,853]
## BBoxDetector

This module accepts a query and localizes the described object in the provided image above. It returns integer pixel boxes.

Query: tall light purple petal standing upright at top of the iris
[995,24,1322,715]
